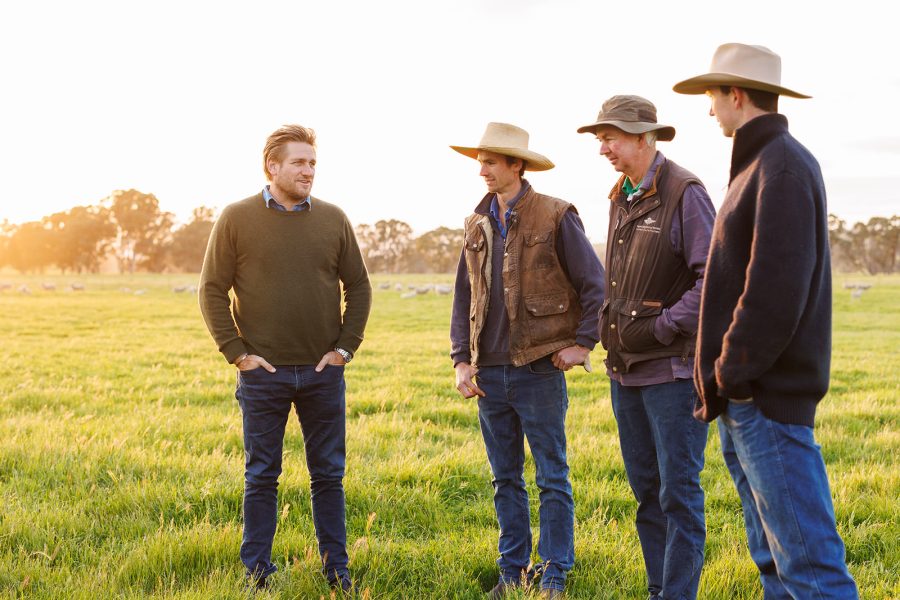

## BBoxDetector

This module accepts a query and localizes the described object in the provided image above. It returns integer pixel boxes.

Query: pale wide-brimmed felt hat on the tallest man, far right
[672,43,812,98]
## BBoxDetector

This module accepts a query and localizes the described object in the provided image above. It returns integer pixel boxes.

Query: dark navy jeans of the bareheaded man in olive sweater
[235,365,348,580]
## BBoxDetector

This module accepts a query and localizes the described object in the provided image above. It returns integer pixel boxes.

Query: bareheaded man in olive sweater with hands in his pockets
[199,125,372,591]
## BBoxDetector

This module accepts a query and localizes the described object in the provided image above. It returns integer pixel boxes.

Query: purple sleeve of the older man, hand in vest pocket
[653,184,716,344]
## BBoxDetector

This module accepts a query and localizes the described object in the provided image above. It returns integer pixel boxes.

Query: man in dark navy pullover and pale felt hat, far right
[674,44,857,598]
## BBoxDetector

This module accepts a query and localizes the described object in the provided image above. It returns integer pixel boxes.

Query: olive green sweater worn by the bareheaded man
[199,193,372,365]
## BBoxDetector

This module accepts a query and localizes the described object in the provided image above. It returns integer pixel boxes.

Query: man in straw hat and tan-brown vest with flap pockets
[450,123,603,598]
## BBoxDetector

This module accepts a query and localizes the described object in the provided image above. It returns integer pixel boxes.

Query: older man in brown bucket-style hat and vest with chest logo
[578,96,715,598]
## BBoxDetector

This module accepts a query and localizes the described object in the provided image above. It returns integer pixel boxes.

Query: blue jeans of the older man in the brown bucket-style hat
[610,379,709,600]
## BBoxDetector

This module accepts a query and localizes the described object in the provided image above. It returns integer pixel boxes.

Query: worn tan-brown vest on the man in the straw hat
[465,189,581,367]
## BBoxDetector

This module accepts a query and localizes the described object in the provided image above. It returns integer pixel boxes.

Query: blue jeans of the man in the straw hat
[478,357,575,590]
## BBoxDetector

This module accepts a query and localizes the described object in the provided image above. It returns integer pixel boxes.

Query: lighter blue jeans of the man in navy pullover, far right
[719,401,858,600]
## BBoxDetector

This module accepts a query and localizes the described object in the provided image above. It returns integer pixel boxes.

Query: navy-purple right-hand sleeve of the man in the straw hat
[556,210,606,350]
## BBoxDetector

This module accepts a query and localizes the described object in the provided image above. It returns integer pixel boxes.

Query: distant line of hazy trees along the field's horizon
[0,190,900,274]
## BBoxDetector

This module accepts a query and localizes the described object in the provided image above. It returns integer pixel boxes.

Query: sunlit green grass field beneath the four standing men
[0,275,900,600]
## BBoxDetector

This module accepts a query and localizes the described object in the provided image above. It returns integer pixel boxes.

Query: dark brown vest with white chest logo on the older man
[600,160,702,373]
